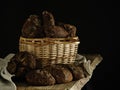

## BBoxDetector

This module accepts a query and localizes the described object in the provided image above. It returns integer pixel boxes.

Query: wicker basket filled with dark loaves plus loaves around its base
[7,11,85,86]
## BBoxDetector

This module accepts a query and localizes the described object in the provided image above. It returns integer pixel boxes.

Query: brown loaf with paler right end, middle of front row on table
[44,65,73,84]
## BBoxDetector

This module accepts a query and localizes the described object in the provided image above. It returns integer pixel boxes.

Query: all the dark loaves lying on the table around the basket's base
[7,51,86,86]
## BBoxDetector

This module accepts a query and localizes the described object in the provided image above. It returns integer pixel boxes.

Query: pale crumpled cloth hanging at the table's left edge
[0,54,16,90]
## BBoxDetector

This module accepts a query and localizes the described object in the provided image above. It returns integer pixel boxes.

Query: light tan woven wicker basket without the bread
[19,37,80,65]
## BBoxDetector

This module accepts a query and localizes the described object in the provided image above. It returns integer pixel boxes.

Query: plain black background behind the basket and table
[0,0,117,90]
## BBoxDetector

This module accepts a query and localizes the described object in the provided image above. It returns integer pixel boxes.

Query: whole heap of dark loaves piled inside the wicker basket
[22,11,76,38]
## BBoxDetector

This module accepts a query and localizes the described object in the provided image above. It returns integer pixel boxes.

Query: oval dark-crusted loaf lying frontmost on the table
[25,69,55,86]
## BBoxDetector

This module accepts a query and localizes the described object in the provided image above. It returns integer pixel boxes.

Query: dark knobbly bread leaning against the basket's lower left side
[7,51,36,77]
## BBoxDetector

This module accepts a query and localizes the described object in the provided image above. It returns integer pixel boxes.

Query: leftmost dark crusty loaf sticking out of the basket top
[22,15,45,38]
